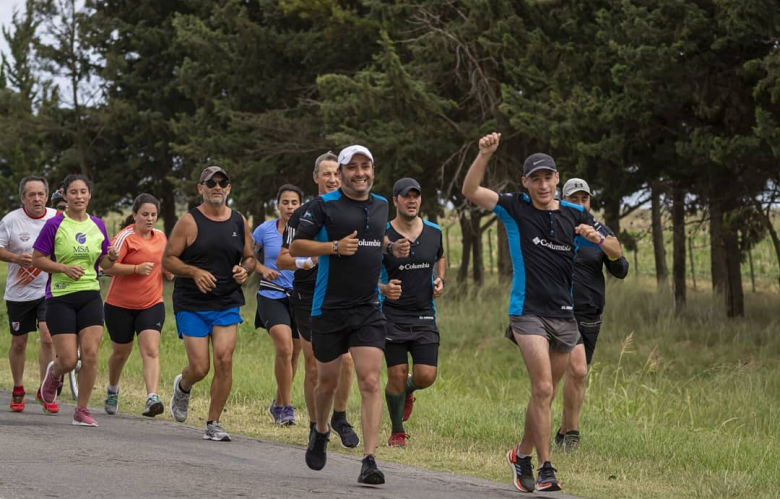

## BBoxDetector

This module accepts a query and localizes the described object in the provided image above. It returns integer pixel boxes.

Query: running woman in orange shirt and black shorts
[103,194,173,417]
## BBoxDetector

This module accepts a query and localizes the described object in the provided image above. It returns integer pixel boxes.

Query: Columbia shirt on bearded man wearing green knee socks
[380,220,444,328]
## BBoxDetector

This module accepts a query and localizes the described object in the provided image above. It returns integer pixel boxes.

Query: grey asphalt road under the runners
[0,391,576,499]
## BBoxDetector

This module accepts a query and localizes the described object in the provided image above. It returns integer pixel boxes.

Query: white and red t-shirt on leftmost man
[0,208,57,301]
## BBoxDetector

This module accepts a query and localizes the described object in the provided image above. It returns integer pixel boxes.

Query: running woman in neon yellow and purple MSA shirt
[33,174,118,426]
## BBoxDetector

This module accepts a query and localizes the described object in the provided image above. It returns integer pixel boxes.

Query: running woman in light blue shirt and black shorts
[252,184,303,426]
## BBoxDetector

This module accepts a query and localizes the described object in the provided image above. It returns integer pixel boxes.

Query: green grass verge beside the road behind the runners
[0,272,780,498]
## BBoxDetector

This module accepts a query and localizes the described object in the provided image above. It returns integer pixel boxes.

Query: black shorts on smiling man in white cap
[311,305,385,362]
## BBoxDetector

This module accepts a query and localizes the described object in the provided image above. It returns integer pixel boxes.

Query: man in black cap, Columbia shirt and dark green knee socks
[379,178,447,447]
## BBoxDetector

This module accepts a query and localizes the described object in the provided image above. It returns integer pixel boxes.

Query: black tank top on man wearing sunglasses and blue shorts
[173,208,246,312]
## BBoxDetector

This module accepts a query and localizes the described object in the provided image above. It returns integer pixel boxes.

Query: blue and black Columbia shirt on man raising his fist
[493,193,607,319]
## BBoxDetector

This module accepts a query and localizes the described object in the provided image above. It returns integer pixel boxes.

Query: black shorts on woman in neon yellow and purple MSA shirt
[46,291,103,336]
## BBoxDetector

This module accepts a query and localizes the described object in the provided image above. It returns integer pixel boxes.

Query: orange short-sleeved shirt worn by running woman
[106,224,167,310]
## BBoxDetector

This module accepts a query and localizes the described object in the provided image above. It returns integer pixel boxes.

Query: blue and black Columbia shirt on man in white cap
[294,189,388,317]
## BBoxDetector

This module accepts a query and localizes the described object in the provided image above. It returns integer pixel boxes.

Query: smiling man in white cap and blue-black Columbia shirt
[290,145,388,485]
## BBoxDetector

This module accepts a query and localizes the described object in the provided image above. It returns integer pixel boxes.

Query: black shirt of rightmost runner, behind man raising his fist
[574,225,628,317]
